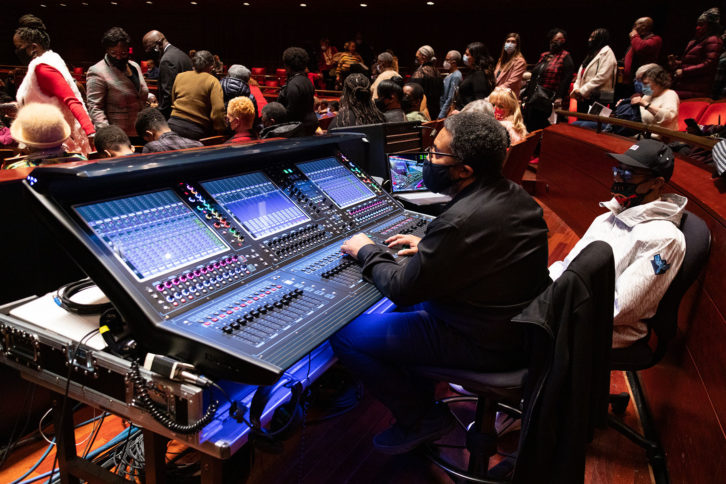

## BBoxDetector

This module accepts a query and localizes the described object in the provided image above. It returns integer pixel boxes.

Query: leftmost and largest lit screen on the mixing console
[74,190,228,280]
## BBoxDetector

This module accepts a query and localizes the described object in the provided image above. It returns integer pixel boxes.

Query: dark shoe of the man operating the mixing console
[373,406,456,455]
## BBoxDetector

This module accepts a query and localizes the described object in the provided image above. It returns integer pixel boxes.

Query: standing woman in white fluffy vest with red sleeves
[13,15,96,156]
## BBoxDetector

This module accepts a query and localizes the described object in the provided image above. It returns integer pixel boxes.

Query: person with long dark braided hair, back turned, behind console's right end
[329,74,386,128]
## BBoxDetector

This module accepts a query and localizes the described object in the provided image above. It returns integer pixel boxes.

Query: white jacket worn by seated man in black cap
[550,193,688,348]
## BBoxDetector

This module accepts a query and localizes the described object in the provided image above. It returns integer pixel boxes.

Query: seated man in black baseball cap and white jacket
[550,139,688,348]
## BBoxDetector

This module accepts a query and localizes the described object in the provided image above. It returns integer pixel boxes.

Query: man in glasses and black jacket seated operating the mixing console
[331,113,549,454]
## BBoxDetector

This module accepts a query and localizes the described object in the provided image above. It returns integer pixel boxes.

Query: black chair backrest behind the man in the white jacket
[648,211,711,366]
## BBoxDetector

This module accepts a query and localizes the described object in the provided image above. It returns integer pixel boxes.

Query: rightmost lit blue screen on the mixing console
[297,158,375,208]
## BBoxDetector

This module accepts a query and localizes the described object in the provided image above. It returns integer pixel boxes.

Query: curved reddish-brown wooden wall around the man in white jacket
[537,125,726,483]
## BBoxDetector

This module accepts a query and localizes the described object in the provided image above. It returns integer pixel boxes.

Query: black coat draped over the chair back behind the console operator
[512,241,615,484]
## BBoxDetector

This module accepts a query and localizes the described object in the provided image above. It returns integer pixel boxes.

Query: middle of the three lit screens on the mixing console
[202,172,310,239]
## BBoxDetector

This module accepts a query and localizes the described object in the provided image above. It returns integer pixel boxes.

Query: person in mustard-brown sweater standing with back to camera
[169,50,225,140]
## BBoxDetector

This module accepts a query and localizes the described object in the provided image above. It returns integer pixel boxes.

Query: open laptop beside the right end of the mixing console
[386,153,451,205]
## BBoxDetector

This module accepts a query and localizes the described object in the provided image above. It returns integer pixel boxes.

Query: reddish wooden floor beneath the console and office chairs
[0,199,652,484]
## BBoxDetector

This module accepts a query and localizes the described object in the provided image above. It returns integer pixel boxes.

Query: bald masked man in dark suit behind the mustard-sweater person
[142,30,192,119]
